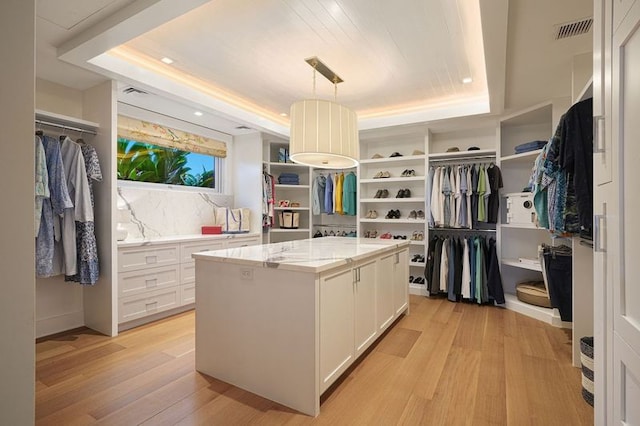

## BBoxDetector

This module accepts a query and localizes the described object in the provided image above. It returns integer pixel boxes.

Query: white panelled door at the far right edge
[608,0,640,425]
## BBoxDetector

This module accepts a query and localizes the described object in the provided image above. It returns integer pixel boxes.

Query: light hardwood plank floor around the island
[36,296,593,426]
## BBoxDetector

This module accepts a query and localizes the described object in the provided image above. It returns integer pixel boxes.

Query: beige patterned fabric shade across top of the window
[118,115,227,158]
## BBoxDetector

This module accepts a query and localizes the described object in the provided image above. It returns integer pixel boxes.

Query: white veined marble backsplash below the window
[118,185,233,240]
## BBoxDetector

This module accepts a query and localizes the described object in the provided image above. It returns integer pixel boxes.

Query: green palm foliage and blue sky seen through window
[118,138,215,188]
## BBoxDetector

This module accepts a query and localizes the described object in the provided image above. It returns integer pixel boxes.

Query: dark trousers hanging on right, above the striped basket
[544,246,573,321]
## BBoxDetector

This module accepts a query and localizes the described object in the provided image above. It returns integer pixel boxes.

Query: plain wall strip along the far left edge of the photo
[0,0,35,425]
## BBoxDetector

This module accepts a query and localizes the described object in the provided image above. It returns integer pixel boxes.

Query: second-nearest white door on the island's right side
[355,259,378,358]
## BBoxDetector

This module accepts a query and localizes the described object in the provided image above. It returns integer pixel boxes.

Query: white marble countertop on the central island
[193,237,409,273]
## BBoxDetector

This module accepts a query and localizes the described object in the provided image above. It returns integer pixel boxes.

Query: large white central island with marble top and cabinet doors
[193,237,409,416]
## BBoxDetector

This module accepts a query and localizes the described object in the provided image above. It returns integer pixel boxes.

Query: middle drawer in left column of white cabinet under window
[118,265,180,297]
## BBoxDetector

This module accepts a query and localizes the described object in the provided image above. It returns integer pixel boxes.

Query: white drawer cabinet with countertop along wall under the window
[118,235,260,329]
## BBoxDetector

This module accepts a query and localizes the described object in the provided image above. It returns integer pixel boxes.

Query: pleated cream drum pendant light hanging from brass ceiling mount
[289,57,359,169]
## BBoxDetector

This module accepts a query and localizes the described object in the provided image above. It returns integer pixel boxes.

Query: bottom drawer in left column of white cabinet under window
[118,286,180,323]
